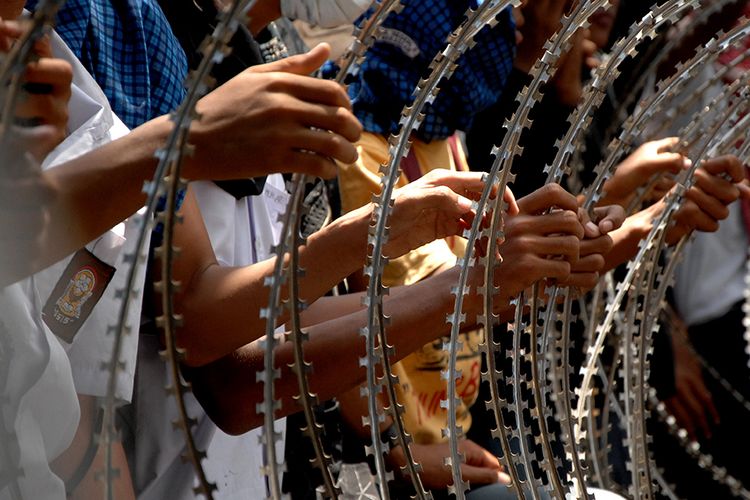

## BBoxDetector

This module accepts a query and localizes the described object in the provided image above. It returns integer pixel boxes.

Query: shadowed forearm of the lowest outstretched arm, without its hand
[190,271,458,433]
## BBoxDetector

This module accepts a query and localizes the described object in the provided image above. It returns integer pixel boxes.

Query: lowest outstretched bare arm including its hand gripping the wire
[188,186,583,433]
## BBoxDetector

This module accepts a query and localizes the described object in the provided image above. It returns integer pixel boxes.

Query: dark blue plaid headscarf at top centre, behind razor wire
[349,0,515,142]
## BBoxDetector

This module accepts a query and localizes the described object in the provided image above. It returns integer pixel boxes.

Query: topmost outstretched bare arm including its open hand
[0,46,361,285]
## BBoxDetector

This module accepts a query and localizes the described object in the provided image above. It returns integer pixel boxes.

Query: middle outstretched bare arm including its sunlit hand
[175,170,484,366]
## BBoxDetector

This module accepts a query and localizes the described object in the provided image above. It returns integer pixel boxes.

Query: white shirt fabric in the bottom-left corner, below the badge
[0,278,80,500]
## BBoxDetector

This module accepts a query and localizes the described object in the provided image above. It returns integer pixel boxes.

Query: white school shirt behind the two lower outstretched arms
[133,174,289,500]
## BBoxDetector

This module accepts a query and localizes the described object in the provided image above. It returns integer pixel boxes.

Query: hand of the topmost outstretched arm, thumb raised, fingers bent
[186,44,362,180]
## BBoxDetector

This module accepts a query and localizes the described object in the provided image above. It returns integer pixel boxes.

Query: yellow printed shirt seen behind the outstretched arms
[339,132,481,444]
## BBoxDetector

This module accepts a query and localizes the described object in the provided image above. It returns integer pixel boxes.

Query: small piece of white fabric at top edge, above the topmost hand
[280,0,372,28]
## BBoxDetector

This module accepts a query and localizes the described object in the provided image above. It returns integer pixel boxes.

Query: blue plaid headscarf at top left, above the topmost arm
[27,0,188,128]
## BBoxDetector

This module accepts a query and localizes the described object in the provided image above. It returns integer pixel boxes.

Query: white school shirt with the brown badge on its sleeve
[34,30,146,401]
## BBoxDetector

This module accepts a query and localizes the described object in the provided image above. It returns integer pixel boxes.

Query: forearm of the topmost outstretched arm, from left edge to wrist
[0,115,171,284]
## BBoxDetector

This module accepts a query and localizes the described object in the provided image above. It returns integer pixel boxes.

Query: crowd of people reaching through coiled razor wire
[0,0,750,500]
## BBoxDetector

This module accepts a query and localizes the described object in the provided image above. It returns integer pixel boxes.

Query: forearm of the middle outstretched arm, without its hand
[177,201,370,366]
